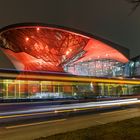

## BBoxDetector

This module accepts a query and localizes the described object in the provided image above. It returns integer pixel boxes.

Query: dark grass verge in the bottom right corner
[36,117,140,140]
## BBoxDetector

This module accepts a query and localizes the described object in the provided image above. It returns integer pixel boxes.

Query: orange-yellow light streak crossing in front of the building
[0,72,140,85]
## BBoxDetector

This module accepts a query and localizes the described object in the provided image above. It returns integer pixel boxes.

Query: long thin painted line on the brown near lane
[5,119,67,129]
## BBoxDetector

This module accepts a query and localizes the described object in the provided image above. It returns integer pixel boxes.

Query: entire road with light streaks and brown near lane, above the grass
[0,98,140,140]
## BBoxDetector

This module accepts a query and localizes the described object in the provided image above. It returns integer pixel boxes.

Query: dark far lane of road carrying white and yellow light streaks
[0,98,140,127]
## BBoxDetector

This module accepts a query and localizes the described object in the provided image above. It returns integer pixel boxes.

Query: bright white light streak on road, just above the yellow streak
[0,98,140,116]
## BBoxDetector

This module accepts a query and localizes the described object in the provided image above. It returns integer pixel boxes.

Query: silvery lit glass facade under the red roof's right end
[65,59,124,77]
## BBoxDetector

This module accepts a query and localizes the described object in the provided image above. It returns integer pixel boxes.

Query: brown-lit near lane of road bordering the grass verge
[0,107,140,140]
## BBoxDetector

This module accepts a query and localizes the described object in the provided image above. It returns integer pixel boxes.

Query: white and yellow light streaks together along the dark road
[0,98,140,119]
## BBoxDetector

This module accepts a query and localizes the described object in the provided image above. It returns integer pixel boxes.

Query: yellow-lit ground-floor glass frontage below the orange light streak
[0,79,140,99]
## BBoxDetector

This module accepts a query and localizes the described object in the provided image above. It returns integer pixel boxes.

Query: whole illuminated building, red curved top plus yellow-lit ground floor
[0,24,139,99]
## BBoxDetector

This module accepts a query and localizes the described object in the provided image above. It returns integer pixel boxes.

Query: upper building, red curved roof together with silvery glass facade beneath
[0,24,129,77]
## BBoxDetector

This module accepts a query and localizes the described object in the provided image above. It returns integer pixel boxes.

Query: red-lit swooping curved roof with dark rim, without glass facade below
[0,23,128,71]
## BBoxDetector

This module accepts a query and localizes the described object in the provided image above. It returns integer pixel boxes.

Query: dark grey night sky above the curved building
[0,0,140,57]
